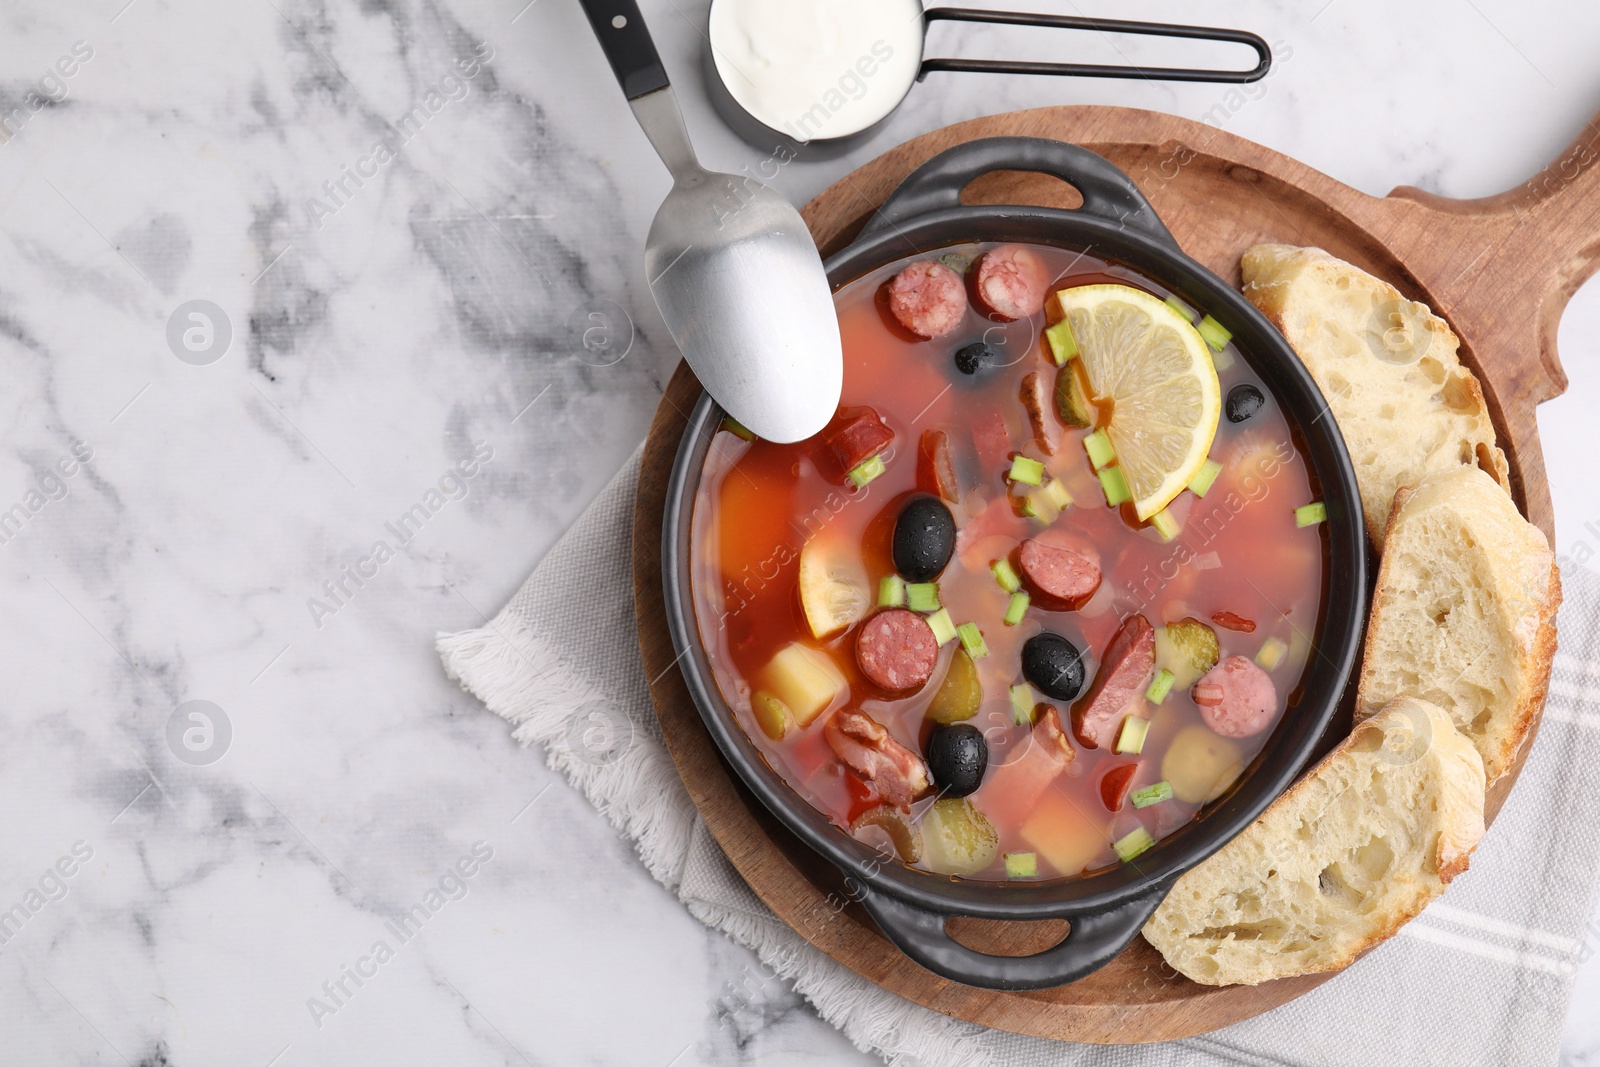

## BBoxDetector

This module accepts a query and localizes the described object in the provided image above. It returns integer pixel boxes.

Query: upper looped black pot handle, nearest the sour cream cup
[861,138,1178,250]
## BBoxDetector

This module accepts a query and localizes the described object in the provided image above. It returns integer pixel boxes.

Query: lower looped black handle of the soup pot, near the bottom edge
[856,881,1171,989]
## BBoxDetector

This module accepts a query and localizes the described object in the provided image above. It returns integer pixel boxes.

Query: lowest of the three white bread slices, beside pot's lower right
[1144,697,1483,985]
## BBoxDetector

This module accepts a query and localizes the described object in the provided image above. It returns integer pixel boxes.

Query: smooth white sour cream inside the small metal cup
[710,0,922,142]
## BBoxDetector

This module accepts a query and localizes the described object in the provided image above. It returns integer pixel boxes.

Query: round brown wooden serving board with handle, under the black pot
[634,107,1600,1043]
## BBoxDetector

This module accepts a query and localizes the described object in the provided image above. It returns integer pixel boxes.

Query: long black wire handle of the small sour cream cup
[917,8,1272,85]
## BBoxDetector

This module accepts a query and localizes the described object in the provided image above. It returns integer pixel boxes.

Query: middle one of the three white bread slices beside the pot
[1355,467,1562,782]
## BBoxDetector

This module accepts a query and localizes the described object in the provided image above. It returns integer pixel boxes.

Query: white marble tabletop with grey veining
[0,0,1600,1067]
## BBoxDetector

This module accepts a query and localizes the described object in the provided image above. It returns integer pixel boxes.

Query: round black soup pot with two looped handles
[662,138,1368,989]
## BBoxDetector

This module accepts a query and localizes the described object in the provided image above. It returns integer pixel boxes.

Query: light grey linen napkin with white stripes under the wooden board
[438,453,1600,1067]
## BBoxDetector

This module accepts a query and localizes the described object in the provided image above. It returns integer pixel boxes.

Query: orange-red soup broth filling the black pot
[691,245,1323,881]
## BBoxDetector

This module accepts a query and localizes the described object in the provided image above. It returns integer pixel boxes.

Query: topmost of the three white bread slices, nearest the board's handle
[1242,245,1510,550]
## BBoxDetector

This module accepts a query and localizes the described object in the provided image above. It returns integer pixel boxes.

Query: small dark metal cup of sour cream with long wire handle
[702,0,1272,158]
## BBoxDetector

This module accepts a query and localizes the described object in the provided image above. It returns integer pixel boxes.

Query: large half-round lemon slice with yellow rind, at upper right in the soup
[1056,285,1222,522]
